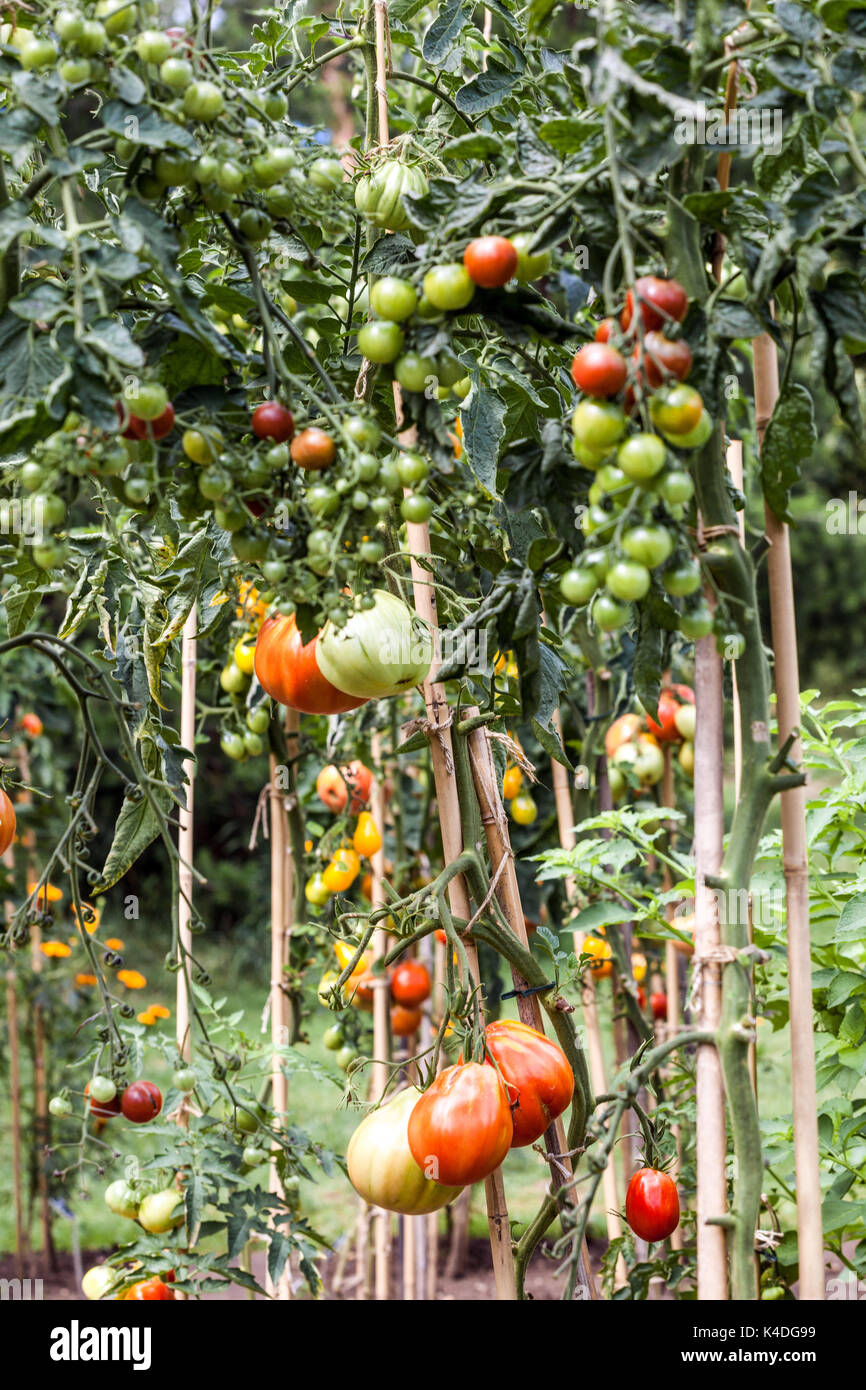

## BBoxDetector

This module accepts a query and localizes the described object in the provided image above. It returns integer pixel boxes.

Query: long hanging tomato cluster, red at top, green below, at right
[560,275,713,638]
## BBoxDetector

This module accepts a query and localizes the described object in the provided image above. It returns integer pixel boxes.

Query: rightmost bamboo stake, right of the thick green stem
[753,334,826,1301]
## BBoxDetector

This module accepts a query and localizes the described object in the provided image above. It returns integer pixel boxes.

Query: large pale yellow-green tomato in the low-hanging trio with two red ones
[346,1086,460,1216]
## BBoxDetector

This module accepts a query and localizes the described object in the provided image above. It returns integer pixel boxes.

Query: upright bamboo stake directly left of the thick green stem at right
[695,614,728,1301]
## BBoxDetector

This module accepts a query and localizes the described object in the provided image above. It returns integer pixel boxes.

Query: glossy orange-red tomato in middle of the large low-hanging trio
[409,1062,514,1187]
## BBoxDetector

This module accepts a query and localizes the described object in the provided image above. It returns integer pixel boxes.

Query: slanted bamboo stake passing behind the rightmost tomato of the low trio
[468,728,598,1298]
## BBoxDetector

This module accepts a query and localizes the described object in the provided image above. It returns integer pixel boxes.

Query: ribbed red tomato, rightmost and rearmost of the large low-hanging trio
[484,1019,574,1148]
